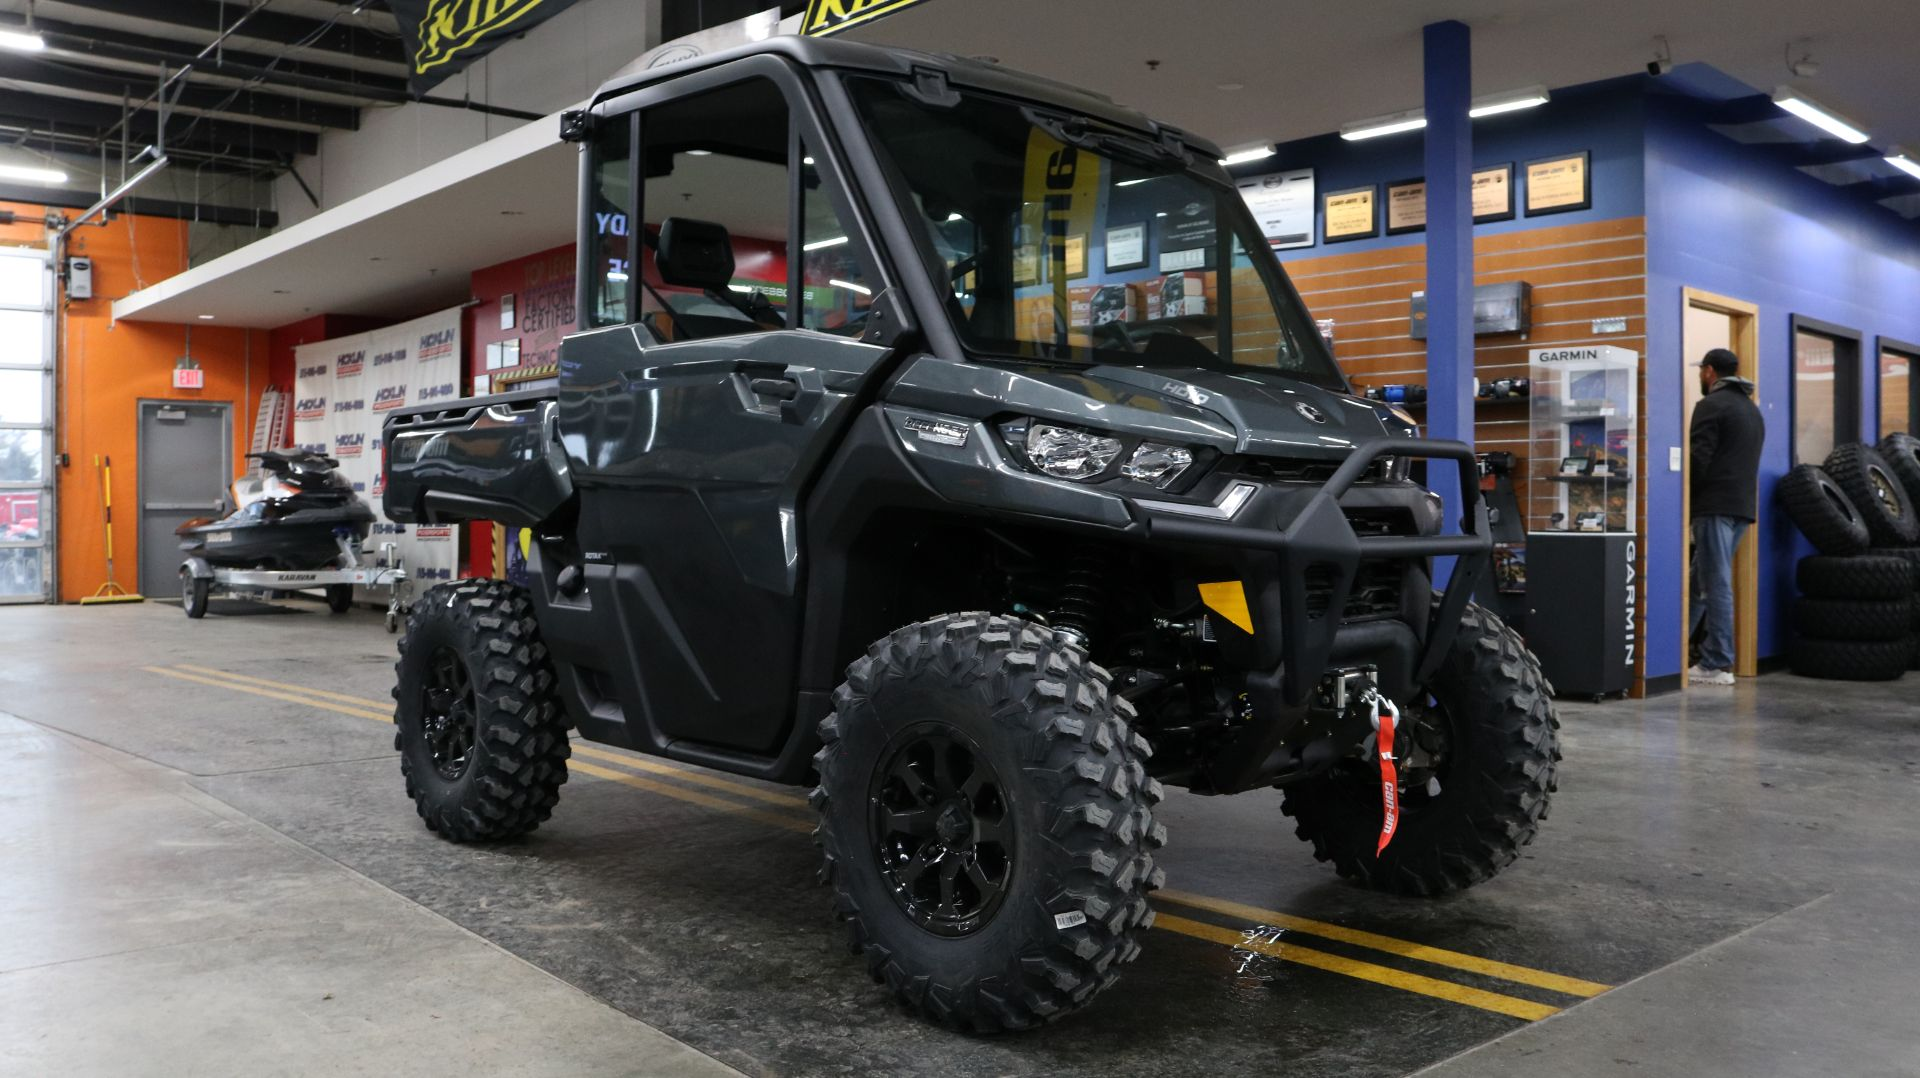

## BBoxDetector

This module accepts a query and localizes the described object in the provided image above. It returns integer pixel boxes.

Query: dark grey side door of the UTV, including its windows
[549,58,897,767]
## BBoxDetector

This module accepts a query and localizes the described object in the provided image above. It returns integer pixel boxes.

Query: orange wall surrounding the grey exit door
[0,202,267,601]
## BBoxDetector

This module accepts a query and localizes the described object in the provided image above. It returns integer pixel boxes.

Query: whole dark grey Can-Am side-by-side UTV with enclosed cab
[384,38,1559,1030]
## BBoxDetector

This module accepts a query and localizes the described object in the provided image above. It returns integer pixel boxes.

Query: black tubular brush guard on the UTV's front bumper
[1146,438,1494,707]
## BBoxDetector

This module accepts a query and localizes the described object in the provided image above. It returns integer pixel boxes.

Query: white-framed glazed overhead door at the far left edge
[0,248,54,603]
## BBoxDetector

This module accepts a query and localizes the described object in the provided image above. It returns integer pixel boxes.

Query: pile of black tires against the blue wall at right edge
[1780,434,1920,680]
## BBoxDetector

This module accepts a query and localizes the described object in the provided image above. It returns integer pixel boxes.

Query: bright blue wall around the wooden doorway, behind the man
[1644,86,1920,678]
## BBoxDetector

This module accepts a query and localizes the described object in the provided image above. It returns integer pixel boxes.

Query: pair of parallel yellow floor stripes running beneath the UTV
[142,665,1607,1022]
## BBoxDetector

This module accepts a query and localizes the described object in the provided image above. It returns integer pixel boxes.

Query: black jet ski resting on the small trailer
[175,450,372,571]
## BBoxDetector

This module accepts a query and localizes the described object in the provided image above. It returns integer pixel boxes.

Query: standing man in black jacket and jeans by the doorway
[1688,348,1766,684]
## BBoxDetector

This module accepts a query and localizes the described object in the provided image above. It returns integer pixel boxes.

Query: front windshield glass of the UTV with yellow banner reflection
[849,77,1344,388]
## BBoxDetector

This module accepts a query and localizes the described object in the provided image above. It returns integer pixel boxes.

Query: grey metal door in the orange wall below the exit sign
[137,400,234,596]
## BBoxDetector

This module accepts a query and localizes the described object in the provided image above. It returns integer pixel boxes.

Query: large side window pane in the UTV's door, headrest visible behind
[639,79,791,342]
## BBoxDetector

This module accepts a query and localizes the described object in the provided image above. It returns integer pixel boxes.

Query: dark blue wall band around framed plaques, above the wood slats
[1233,77,1645,259]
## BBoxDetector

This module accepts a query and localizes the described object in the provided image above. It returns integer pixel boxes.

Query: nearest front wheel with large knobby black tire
[812,613,1165,1032]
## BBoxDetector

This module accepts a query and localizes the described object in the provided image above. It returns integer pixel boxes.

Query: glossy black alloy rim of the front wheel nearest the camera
[868,723,1014,938]
